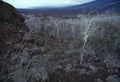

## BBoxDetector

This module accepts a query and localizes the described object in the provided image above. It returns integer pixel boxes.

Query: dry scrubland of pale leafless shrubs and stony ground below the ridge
[0,14,120,82]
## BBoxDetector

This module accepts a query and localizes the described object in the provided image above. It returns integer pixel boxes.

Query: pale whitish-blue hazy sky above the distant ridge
[3,0,93,8]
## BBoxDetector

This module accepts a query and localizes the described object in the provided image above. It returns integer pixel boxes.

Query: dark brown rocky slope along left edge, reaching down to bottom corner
[0,1,29,82]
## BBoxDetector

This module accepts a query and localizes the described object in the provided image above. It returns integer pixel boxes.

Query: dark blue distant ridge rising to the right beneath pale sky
[19,0,120,16]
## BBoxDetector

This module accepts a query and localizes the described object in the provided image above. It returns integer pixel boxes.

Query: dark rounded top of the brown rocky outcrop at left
[0,1,29,31]
